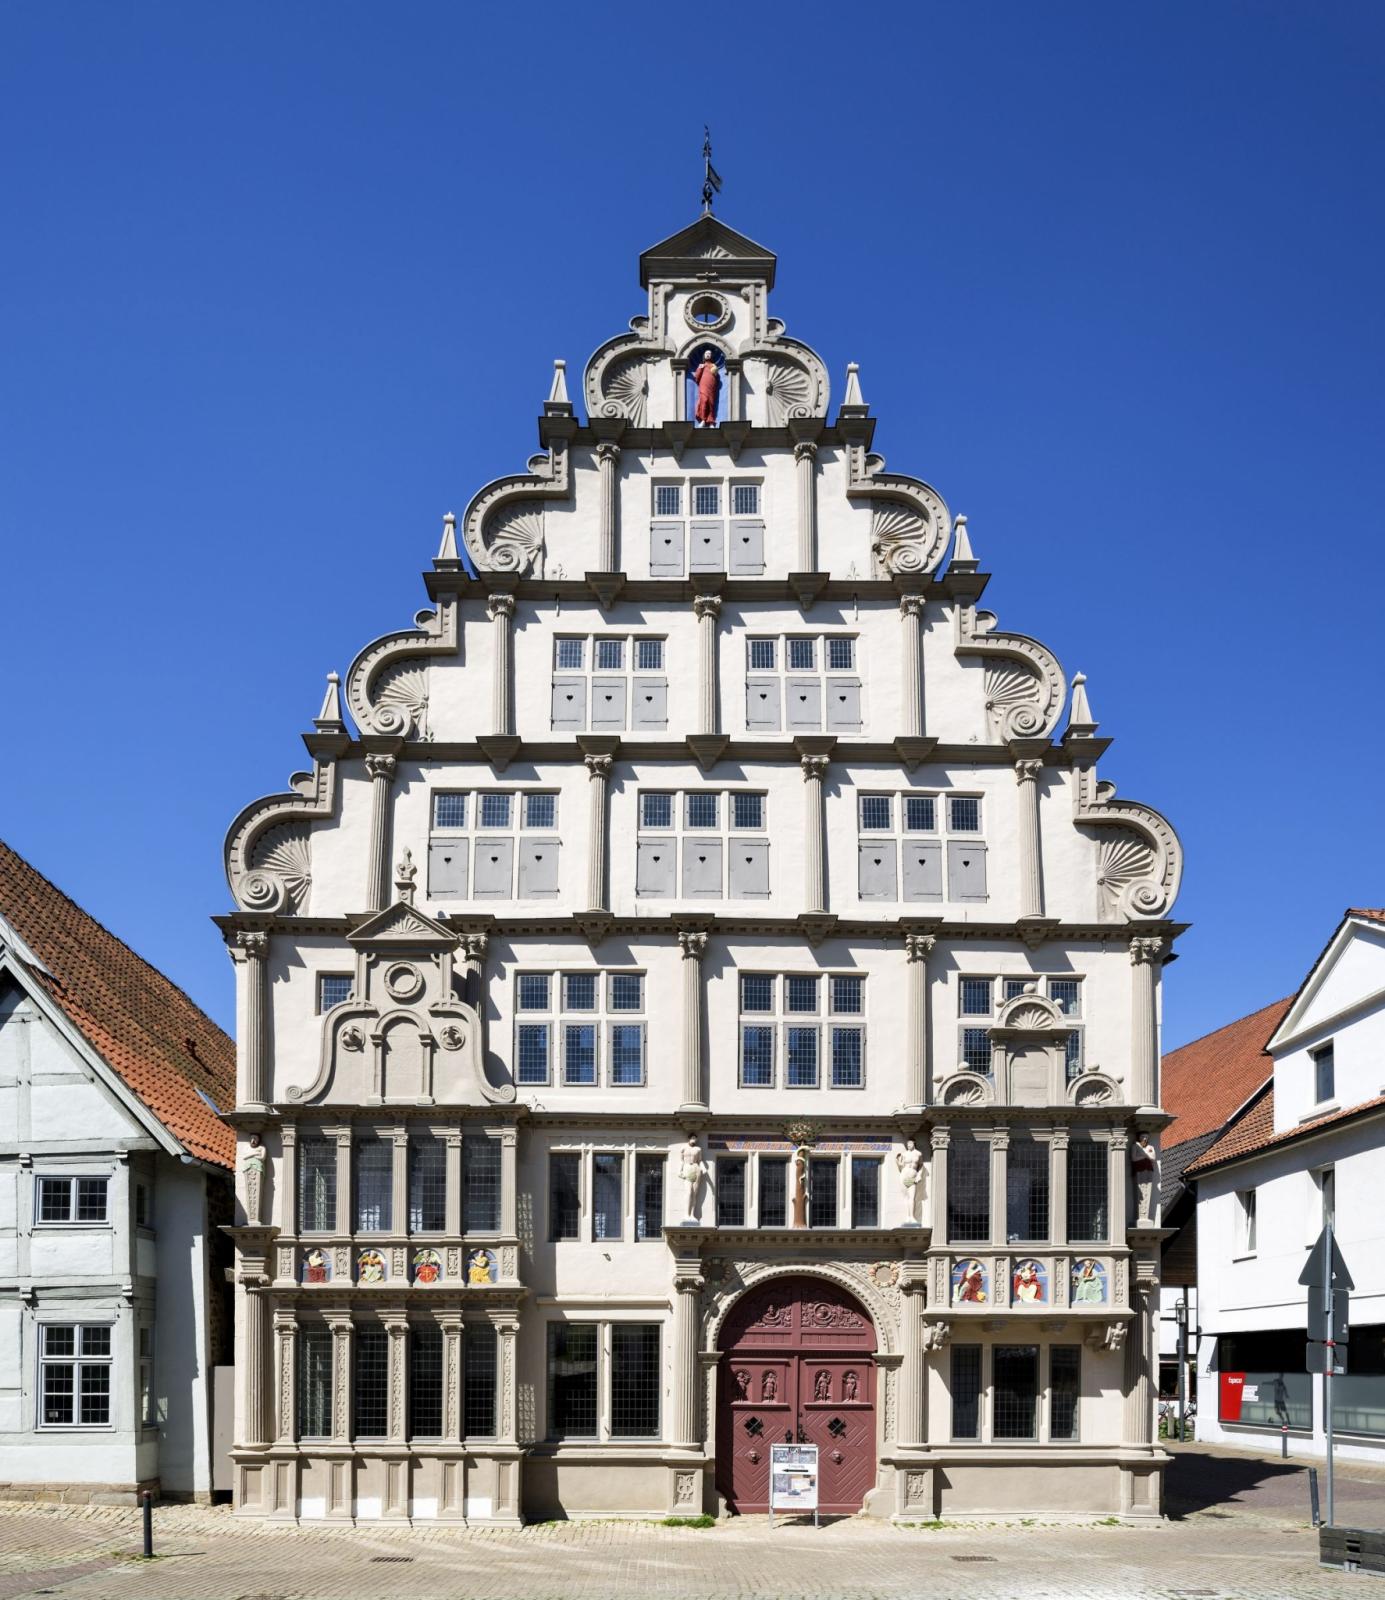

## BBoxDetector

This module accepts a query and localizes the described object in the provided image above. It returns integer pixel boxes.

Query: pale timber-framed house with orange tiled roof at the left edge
[0,843,235,1501]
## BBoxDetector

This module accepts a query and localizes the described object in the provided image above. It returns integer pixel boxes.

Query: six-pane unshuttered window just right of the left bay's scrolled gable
[515,970,648,1090]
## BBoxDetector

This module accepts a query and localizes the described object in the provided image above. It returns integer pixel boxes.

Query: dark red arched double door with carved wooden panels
[716,1274,875,1515]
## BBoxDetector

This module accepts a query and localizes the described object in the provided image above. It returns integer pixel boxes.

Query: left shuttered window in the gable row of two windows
[550,634,669,733]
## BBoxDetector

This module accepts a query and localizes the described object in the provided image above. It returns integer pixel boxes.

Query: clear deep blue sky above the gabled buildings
[0,0,1385,1045]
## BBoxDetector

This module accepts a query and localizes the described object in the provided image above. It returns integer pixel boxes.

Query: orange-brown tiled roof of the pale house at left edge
[0,840,235,1166]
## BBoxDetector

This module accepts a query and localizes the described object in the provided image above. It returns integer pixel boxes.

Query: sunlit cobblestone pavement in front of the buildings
[0,1446,1385,1600]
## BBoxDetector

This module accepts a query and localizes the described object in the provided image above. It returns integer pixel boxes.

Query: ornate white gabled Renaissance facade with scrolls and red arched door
[221,216,1180,1522]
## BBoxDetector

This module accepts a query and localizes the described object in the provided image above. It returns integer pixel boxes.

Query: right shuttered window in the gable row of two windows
[745,632,862,733]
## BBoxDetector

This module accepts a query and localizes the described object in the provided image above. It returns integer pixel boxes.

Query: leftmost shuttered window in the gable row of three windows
[429,789,561,901]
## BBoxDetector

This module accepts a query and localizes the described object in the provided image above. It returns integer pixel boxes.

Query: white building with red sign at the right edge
[1187,910,1385,1461]
